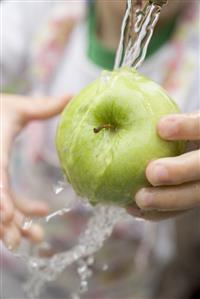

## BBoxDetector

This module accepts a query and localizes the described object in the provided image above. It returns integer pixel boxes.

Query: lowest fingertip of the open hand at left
[3,222,21,250]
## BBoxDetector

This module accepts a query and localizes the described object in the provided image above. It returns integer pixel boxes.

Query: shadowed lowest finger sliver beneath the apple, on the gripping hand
[127,207,186,221]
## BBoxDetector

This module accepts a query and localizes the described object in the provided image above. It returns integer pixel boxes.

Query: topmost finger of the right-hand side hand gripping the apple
[158,112,200,140]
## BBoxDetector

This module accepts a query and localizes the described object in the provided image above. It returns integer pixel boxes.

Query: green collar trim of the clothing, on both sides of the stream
[87,2,178,70]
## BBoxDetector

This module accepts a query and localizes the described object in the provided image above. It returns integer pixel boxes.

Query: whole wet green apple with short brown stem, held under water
[56,68,184,206]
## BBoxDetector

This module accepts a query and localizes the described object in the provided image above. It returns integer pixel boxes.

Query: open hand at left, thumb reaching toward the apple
[0,95,70,248]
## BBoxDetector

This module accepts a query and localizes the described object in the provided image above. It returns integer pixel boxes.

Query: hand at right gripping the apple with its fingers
[130,113,200,220]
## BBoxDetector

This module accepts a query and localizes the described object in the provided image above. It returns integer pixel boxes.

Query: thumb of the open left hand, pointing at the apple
[24,95,72,121]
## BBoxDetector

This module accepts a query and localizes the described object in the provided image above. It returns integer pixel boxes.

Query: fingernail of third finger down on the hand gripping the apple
[135,188,154,210]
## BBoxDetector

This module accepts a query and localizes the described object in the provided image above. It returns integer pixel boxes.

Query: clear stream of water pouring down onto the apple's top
[115,0,167,68]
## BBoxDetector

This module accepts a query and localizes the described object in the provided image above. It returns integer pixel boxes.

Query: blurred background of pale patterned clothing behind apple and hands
[0,0,200,299]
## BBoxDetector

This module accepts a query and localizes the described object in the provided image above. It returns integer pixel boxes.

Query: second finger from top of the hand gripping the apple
[146,151,200,186]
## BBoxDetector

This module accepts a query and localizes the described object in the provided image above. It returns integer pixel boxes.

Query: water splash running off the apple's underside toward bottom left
[22,205,127,299]
